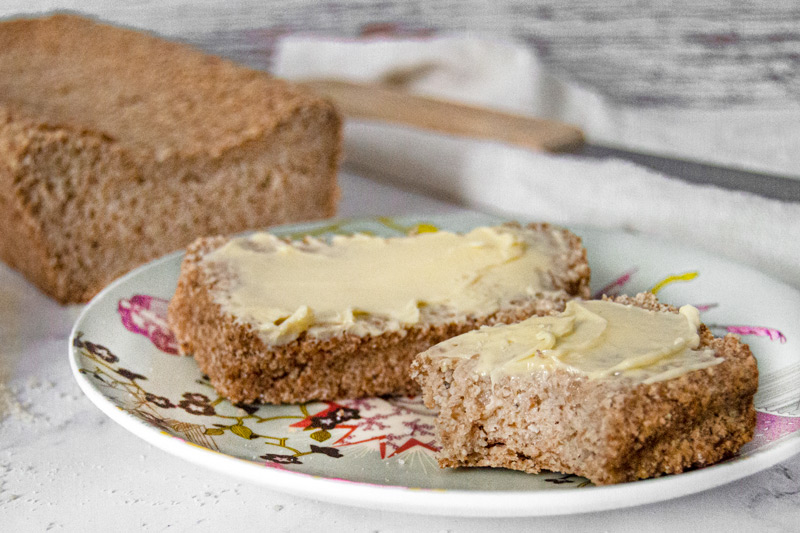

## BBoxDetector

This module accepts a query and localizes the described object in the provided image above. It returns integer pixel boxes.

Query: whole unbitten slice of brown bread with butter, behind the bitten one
[169,224,589,403]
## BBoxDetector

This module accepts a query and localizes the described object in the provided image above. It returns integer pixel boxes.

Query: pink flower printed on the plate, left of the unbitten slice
[117,294,178,355]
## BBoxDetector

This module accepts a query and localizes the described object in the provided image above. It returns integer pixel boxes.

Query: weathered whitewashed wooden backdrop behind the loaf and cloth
[0,0,800,110]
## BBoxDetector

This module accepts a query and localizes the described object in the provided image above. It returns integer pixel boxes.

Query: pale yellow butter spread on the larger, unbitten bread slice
[203,226,562,344]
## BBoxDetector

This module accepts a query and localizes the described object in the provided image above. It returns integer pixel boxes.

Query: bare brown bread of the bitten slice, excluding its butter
[412,294,758,485]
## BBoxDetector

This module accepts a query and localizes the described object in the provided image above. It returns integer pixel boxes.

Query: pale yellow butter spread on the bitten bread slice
[422,300,722,383]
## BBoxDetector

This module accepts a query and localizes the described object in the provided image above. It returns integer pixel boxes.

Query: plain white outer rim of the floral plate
[69,213,800,517]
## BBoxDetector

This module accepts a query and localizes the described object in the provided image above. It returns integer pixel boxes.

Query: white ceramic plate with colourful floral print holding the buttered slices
[70,215,800,516]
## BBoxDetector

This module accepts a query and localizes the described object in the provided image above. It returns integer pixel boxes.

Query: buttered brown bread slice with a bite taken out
[412,294,758,485]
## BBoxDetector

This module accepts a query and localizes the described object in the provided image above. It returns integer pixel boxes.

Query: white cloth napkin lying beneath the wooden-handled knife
[274,36,800,287]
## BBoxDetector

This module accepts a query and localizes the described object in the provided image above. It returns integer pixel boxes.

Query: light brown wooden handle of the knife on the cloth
[303,80,584,152]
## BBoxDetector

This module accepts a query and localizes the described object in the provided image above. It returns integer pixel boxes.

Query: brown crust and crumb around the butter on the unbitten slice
[169,224,590,403]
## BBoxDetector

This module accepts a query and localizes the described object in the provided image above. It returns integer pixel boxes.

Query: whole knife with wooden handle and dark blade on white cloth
[301,79,800,202]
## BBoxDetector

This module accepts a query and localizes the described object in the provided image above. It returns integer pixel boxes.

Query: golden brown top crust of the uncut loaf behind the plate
[0,14,333,160]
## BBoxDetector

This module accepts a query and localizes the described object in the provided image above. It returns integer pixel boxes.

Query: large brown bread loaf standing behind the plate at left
[0,15,341,302]
